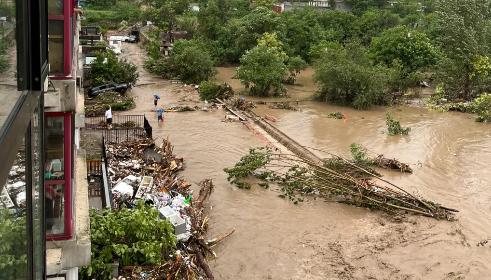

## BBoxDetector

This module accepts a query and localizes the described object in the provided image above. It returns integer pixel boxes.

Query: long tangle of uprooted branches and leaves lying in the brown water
[224,147,458,220]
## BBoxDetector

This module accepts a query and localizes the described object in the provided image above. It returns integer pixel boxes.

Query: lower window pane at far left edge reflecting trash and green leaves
[0,135,28,280]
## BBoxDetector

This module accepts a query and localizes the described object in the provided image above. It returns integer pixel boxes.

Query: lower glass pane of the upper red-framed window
[48,20,64,74]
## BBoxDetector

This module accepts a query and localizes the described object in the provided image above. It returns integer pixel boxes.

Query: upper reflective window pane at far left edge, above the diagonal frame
[0,1,26,132]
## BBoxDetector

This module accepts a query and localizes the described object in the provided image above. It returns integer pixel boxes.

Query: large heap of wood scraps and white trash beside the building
[106,137,233,279]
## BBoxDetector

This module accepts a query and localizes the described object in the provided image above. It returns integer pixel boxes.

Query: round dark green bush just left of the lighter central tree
[171,46,217,84]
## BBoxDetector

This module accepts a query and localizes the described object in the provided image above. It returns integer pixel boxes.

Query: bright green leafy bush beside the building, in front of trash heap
[80,200,176,280]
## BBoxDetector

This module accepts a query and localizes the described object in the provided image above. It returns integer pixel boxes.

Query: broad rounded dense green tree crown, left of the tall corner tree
[369,26,438,73]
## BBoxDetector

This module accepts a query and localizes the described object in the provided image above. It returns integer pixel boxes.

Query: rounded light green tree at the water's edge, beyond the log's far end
[234,44,286,96]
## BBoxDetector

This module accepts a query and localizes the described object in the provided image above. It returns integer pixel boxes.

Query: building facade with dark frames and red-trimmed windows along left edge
[0,0,90,280]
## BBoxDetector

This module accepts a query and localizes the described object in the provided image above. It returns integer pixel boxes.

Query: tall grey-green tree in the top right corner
[435,0,491,100]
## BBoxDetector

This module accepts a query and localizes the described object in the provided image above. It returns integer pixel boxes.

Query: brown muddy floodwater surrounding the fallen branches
[131,61,491,280]
